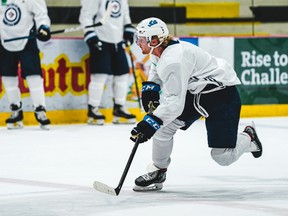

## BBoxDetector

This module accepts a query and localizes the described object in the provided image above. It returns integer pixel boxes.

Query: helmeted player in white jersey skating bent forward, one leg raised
[131,17,262,191]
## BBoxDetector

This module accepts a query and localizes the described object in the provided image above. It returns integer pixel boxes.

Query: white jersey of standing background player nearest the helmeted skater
[79,0,131,43]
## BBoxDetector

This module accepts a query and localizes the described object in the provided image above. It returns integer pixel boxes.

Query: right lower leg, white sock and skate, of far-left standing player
[26,75,51,130]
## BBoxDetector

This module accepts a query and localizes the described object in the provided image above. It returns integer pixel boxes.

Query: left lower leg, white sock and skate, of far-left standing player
[2,76,23,129]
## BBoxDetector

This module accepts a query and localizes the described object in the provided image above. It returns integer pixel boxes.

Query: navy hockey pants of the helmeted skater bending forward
[177,86,241,148]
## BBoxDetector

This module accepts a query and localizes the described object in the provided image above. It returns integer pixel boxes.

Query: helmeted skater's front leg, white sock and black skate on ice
[133,119,185,192]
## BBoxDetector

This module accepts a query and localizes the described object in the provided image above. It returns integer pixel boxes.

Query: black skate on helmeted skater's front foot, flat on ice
[133,169,167,192]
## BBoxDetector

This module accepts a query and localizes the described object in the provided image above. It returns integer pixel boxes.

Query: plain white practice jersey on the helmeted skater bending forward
[148,41,241,125]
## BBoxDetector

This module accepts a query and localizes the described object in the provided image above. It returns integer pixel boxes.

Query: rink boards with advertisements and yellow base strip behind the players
[0,37,288,125]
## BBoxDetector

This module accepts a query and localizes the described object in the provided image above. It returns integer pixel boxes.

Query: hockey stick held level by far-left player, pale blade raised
[4,3,112,43]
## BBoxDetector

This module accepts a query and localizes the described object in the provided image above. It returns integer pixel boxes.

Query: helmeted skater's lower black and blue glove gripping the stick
[130,114,163,143]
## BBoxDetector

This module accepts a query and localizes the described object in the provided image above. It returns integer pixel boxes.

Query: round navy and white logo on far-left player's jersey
[3,4,21,26]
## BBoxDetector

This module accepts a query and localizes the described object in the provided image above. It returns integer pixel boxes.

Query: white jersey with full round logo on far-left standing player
[0,0,50,51]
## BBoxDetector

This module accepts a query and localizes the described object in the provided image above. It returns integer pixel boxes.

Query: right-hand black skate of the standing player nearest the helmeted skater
[113,104,136,124]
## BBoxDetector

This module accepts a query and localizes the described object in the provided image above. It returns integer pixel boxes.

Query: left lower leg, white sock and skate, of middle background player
[88,74,108,125]
